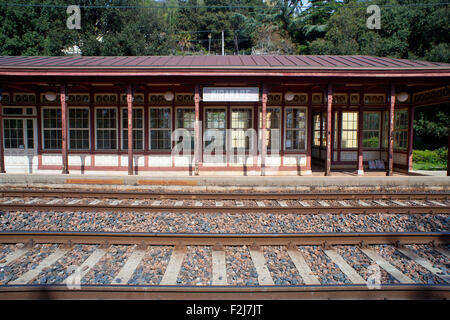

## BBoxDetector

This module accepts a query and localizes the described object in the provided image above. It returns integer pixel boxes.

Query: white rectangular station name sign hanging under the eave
[203,87,259,102]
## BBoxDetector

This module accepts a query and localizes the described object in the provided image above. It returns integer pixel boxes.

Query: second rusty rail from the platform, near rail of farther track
[0,203,450,214]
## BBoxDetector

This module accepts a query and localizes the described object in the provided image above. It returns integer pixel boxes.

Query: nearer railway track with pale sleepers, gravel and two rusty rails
[0,232,450,299]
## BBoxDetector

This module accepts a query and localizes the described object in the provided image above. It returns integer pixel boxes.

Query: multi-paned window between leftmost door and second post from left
[42,108,62,150]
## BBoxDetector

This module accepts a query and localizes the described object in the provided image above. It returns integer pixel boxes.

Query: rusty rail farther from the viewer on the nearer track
[0,231,450,246]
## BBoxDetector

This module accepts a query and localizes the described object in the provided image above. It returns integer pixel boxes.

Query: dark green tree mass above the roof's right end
[299,0,450,62]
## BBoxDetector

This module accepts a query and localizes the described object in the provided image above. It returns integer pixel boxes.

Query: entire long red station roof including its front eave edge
[0,56,450,82]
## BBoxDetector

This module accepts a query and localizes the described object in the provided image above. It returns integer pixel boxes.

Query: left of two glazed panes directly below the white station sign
[205,108,227,152]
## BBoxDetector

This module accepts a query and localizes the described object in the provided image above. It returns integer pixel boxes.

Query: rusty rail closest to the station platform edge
[0,189,450,200]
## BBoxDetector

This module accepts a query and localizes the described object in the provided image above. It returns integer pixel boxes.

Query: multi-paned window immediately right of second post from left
[69,108,89,150]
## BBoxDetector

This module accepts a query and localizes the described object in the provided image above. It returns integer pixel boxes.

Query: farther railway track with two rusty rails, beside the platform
[0,190,450,214]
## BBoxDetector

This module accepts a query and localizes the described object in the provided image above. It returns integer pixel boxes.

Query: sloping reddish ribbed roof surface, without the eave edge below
[0,55,450,70]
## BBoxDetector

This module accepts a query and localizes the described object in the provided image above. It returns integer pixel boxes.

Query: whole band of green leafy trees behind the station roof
[0,0,450,62]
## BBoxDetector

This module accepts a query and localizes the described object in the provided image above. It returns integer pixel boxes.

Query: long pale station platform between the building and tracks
[0,172,450,192]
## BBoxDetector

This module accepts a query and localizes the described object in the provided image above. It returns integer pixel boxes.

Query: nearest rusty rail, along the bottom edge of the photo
[0,284,450,300]
